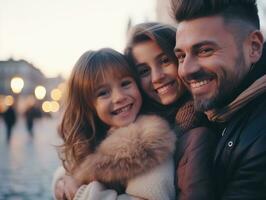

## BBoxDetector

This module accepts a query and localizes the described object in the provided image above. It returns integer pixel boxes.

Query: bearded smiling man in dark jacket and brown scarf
[172,0,266,200]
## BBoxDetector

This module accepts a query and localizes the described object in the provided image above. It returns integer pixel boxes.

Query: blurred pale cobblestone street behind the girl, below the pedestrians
[0,117,59,200]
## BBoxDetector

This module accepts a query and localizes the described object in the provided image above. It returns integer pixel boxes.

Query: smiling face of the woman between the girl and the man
[132,40,184,105]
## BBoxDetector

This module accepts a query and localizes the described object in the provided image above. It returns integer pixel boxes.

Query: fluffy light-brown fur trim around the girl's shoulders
[73,115,176,183]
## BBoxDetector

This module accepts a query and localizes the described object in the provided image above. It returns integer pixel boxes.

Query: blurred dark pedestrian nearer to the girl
[25,105,42,137]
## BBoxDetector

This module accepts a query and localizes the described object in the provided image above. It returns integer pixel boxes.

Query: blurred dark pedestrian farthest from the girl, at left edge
[3,105,17,142]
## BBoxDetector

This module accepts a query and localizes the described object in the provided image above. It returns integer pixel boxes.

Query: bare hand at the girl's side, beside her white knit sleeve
[63,175,82,200]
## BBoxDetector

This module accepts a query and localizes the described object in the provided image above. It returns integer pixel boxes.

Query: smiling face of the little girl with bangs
[94,76,142,127]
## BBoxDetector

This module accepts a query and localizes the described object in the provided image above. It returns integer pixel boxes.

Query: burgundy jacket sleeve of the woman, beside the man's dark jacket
[176,127,217,200]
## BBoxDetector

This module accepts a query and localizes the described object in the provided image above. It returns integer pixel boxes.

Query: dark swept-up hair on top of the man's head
[172,0,260,29]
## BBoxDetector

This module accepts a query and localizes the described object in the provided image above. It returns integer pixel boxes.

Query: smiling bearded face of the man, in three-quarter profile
[175,16,251,111]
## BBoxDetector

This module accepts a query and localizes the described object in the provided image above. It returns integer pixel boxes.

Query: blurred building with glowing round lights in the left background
[0,59,65,114]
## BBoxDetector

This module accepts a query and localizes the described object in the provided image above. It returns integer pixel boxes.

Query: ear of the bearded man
[248,30,264,63]
